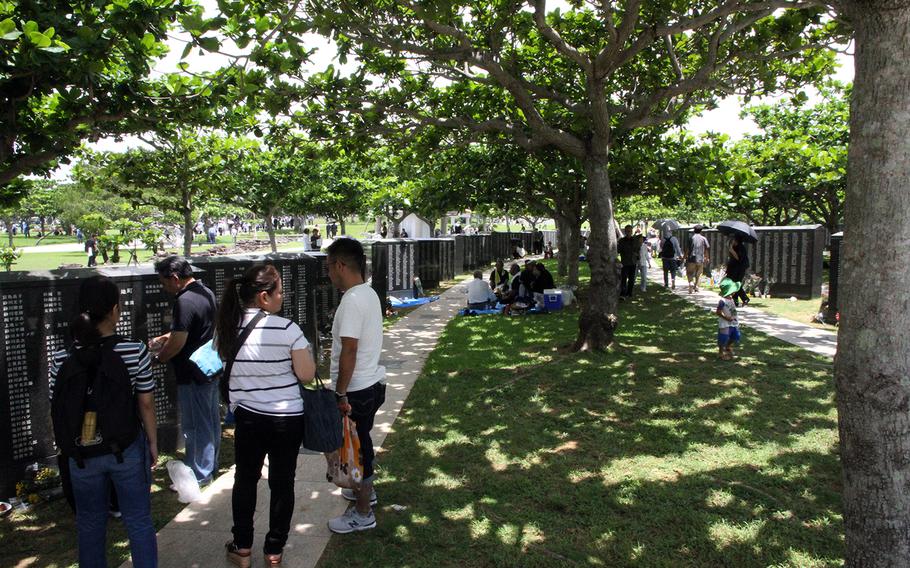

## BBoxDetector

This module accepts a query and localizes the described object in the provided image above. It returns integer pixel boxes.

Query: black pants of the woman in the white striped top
[231,408,303,554]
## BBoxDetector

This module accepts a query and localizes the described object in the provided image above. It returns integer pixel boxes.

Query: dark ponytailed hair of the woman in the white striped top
[215,264,281,361]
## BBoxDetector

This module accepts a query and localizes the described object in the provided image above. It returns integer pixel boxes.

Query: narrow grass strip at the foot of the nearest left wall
[0,427,234,568]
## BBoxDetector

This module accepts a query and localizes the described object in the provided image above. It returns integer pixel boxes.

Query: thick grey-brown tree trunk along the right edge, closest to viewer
[834,0,910,567]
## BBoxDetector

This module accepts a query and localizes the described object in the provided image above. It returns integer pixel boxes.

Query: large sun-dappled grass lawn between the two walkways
[319,262,843,568]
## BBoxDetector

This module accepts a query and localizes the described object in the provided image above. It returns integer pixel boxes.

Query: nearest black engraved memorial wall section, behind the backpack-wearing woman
[0,266,177,495]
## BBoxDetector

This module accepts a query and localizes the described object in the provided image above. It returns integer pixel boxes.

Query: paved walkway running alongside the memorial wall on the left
[123,278,474,568]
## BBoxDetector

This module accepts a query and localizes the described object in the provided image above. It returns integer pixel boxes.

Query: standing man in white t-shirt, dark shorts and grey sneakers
[326,238,385,534]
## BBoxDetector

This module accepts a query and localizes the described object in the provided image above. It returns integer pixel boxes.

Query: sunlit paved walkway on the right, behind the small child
[636,261,837,358]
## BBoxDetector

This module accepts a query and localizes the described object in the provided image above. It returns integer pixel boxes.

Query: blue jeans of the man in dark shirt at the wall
[177,381,221,484]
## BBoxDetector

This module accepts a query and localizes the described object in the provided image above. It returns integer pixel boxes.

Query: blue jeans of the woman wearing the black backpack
[69,433,158,568]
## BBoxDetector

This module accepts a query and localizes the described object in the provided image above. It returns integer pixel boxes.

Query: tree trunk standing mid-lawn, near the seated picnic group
[574,155,619,351]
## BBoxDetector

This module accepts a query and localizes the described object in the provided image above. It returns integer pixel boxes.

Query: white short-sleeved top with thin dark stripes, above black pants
[230,309,310,416]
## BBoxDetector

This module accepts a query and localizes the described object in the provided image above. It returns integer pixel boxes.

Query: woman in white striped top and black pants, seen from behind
[215,265,315,568]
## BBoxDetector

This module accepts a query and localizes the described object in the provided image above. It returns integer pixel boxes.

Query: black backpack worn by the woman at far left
[51,335,140,467]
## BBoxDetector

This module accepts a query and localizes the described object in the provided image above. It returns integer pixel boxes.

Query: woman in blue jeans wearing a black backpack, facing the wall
[49,276,158,568]
